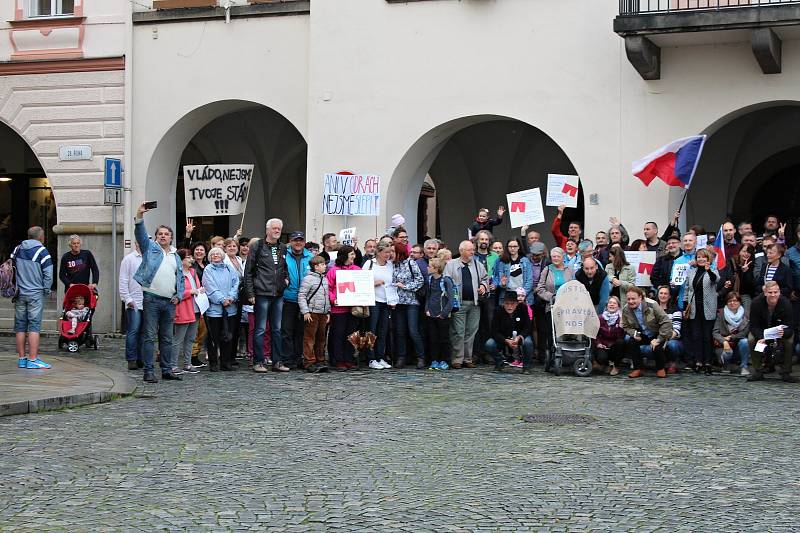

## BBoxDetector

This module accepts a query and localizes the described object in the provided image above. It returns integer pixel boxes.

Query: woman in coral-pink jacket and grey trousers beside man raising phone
[172,248,205,374]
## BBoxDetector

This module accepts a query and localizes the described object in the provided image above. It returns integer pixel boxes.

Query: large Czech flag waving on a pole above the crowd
[632,135,706,189]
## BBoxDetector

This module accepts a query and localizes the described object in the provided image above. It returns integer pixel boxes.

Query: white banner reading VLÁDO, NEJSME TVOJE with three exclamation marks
[183,165,253,217]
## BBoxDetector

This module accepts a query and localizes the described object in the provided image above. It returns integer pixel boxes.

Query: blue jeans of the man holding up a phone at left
[142,292,175,373]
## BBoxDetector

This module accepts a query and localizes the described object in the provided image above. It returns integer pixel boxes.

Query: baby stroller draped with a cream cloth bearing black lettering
[544,280,600,377]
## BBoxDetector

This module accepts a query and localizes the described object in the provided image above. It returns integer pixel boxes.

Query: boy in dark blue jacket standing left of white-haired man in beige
[425,257,456,370]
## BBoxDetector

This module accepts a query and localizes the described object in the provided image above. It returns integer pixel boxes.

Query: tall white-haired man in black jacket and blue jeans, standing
[244,218,289,373]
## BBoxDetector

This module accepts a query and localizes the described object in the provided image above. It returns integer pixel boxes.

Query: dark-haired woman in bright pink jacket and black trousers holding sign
[326,246,361,370]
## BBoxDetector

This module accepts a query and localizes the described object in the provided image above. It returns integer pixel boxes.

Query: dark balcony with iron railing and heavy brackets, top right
[614,0,800,80]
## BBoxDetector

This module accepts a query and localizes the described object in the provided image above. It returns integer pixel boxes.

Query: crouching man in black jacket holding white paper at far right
[747,281,797,383]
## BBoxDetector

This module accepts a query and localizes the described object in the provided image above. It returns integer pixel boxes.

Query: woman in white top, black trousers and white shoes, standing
[363,240,399,370]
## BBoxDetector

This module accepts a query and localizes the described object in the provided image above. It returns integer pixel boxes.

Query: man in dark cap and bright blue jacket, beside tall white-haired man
[281,231,314,372]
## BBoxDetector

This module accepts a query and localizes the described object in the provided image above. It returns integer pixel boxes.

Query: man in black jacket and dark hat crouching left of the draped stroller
[486,291,533,374]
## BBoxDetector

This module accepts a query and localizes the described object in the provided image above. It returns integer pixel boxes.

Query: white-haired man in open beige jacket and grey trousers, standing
[444,241,489,369]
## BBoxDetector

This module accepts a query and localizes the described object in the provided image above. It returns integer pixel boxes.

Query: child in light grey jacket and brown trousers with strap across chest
[297,255,331,373]
